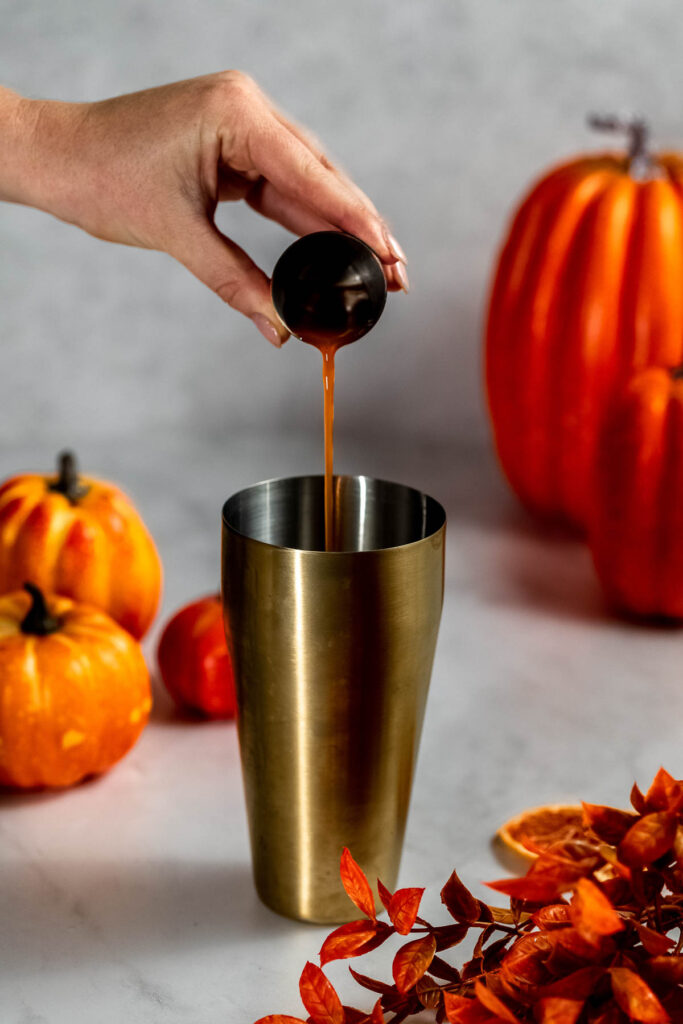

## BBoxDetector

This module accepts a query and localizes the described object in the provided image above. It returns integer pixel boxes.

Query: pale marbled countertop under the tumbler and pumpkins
[0,431,683,1024]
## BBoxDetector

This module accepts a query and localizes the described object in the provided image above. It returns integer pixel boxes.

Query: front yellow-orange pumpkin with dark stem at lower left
[0,584,152,788]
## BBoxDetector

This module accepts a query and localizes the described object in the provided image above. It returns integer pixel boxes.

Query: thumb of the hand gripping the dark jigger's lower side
[169,221,289,348]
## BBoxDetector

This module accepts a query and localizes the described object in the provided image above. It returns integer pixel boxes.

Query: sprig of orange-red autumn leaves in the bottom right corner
[257,768,683,1024]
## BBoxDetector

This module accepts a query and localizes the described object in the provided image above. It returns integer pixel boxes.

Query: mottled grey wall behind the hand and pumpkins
[0,0,683,456]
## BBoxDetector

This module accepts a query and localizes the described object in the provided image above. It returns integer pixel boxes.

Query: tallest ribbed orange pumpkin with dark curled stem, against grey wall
[486,119,683,527]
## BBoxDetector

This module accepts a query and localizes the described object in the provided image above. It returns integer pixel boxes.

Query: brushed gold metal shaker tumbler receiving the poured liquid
[222,476,445,924]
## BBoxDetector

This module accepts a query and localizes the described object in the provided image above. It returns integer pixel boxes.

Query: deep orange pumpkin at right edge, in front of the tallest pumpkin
[589,367,683,618]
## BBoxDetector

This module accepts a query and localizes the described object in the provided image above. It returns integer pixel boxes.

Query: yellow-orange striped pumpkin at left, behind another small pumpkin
[0,453,162,639]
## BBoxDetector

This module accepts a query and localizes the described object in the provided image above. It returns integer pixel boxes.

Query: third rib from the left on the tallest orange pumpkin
[540,175,637,524]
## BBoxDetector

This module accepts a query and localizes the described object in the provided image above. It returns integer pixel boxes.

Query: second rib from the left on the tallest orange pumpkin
[491,170,611,520]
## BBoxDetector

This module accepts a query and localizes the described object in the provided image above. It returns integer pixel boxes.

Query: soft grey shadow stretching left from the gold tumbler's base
[0,860,315,974]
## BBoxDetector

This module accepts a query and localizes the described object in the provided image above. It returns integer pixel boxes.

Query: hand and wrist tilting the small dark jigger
[0,71,408,346]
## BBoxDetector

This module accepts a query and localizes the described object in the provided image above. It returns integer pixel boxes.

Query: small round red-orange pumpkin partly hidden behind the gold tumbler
[157,594,236,718]
